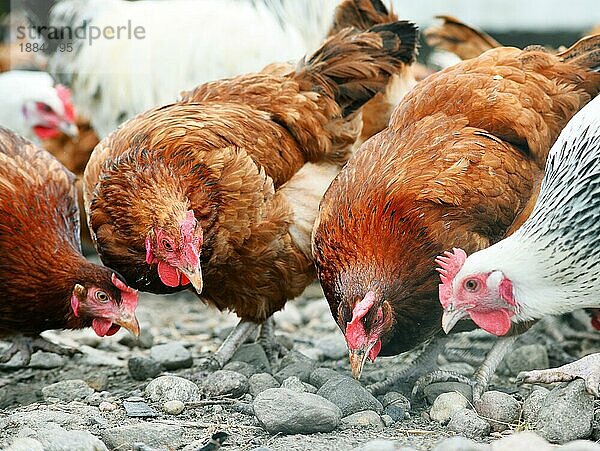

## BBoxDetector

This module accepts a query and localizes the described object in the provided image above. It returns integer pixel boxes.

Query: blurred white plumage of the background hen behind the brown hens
[49,0,337,137]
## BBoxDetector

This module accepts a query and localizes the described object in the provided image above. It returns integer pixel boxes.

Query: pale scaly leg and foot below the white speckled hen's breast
[412,336,517,401]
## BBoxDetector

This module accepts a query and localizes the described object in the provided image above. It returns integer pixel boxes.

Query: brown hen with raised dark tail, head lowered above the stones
[84,22,417,365]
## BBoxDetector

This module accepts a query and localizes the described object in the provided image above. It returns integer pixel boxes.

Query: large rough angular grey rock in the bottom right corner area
[537,379,594,443]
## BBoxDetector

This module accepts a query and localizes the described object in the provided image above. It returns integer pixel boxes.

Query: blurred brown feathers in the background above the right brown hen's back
[423,16,501,60]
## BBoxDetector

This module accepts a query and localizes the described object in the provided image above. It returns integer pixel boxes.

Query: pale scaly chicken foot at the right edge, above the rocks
[517,353,600,397]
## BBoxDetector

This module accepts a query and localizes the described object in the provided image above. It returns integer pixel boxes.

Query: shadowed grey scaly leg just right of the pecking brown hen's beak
[367,336,449,395]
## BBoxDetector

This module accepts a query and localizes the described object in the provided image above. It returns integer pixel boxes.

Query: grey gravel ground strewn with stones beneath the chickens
[0,285,600,451]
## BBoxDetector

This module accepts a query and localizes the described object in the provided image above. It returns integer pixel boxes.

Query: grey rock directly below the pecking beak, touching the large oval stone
[317,378,383,416]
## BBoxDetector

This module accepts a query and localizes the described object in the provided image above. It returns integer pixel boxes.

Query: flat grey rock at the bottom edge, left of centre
[101,421,185,449]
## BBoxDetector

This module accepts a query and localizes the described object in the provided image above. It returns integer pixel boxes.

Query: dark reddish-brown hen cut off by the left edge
[0,127,139,364]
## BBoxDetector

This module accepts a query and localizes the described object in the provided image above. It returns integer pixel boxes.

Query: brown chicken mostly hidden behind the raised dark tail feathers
[329,0,417,148]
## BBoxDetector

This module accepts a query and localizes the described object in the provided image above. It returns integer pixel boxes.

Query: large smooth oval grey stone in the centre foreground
[253,388,342,434]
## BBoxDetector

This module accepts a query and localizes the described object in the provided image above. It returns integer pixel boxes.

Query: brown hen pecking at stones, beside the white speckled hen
[313,36,600,391]
